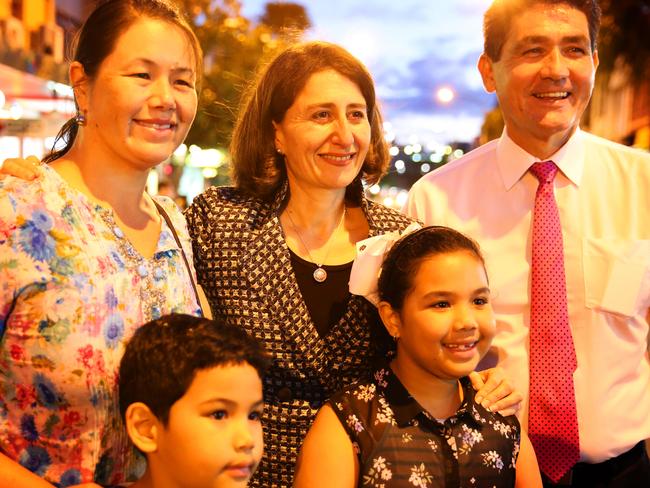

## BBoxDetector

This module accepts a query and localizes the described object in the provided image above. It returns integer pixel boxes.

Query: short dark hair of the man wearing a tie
[483,0,601,62]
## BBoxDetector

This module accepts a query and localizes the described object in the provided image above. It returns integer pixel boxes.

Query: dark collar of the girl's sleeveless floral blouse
[374,364,480,427]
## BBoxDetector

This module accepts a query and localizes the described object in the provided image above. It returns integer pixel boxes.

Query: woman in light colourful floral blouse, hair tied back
[0,0,202,488]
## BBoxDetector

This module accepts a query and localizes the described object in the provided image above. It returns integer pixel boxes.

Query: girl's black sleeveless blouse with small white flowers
[328,365,520,488]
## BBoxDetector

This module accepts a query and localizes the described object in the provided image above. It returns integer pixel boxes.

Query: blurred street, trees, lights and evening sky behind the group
[0,0,650,207]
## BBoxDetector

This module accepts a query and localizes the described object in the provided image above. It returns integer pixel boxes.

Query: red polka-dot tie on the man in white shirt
[528,161,580,482]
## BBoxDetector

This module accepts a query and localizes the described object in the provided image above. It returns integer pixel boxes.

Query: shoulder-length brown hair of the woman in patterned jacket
[230,42,389,200]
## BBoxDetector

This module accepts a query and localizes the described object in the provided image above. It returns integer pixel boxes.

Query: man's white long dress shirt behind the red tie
[405,129,650,463]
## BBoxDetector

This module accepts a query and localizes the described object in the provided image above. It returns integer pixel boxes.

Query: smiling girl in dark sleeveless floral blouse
[294,227,541,488]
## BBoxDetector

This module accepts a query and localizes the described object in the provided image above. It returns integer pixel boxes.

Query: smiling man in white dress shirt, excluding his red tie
[406,0,650,487]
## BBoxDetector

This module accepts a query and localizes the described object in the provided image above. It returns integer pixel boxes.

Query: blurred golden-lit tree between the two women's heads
[175,0,309,149]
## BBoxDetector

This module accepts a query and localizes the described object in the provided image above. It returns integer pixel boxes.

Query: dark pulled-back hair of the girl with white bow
[378,226,485,310]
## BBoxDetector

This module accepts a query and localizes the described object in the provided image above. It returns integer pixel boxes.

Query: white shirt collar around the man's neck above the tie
[497,127,585,190]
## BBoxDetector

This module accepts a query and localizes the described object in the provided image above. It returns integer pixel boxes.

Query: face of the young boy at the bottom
[149,363,263,488]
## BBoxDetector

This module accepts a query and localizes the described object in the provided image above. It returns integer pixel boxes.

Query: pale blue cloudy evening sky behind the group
[244,0,495,142]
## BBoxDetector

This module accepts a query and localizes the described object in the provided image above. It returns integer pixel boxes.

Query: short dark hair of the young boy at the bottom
[119,314,269,425]
